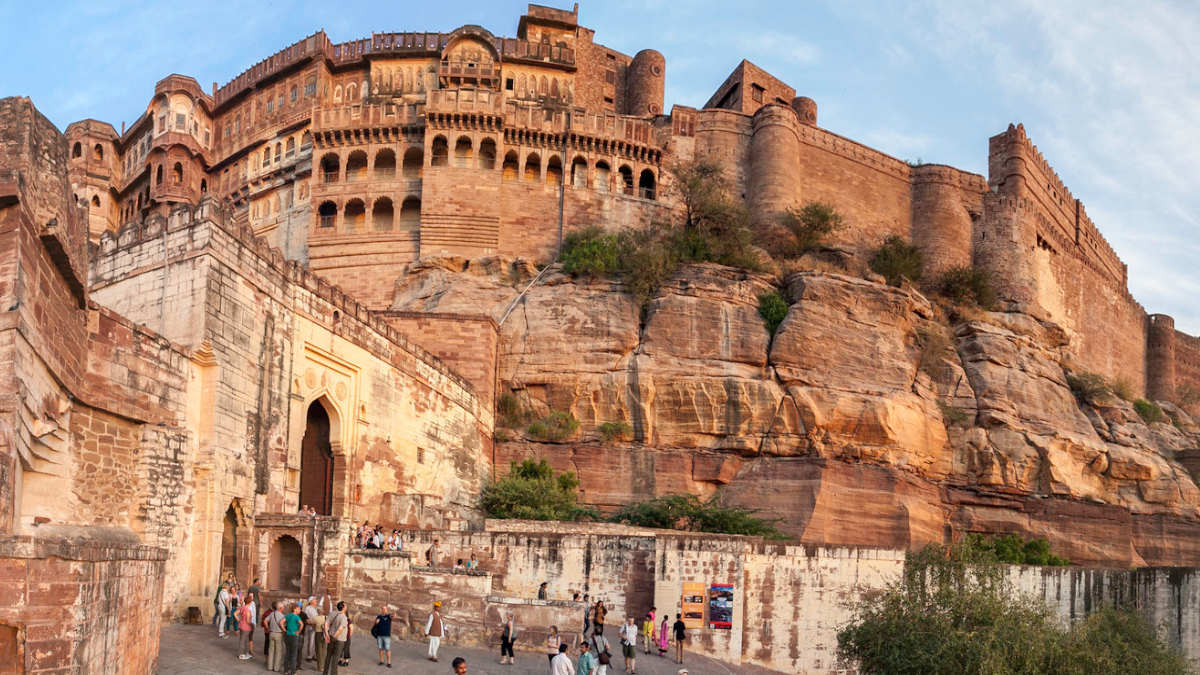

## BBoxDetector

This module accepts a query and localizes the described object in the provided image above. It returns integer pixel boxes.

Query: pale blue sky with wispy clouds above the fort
[7,0,1200,334]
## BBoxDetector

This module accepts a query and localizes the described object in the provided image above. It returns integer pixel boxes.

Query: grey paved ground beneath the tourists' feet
[158,623,773,675]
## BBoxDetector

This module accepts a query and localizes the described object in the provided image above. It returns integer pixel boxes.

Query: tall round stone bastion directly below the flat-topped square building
[746,103,800,219]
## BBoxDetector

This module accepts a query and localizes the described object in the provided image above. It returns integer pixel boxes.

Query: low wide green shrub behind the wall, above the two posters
[610,494,784,539]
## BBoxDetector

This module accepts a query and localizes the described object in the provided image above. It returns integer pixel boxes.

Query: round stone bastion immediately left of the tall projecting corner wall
[912,165,972,279]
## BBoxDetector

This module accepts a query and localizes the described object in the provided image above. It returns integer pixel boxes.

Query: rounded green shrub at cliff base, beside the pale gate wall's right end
[480,459,595,520]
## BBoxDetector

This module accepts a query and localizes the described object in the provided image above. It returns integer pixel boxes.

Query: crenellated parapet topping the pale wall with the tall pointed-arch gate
[94,197,474,394]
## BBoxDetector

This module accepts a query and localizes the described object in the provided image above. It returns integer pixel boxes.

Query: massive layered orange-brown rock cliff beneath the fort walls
[394,258,1200,566]
